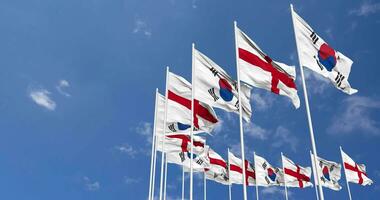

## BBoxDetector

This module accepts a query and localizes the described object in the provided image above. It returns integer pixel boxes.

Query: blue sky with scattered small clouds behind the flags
[0,0,380,200]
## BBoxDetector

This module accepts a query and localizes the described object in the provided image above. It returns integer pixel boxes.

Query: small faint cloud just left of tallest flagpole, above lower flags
[272,126,298,152]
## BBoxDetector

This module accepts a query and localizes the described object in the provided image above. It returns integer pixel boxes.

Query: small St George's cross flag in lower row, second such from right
[282,156,313,188]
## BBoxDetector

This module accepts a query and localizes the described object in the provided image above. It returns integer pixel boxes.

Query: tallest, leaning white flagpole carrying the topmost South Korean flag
[290,4,325,200]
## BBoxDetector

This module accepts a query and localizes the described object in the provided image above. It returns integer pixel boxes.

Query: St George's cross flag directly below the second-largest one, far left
[157,133,205,153]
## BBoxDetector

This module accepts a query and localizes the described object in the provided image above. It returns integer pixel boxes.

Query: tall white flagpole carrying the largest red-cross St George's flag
[234,21,247,200]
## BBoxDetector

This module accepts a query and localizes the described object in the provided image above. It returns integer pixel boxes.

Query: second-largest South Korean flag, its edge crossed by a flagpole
[193,49,252,121]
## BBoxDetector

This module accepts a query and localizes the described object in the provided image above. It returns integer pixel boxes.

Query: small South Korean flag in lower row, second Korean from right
[254,154,284,187]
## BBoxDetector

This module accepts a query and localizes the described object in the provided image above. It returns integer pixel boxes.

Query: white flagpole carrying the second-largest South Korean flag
[189,43,195,200]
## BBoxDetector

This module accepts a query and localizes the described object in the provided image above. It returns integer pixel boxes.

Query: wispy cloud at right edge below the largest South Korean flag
[327,96,380,135]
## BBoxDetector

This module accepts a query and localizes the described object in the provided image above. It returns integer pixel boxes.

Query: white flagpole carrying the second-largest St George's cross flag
[160,67,169,200]
